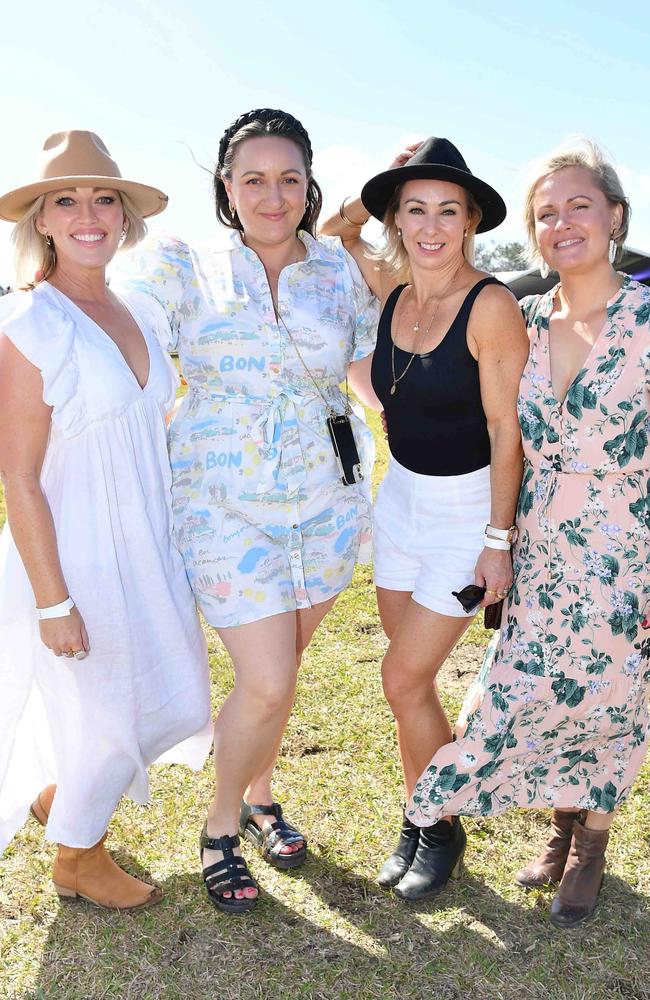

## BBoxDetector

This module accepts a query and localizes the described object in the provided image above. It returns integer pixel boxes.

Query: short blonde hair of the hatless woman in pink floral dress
[524,139,632,265]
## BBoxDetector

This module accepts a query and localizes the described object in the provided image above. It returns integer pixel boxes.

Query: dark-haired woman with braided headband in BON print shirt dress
[118,109,378,912]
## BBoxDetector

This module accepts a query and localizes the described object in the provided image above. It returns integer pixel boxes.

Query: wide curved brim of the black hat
[361,163,508,233]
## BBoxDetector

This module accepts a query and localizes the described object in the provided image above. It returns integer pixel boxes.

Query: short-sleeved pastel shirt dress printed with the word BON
[115,232,378,627]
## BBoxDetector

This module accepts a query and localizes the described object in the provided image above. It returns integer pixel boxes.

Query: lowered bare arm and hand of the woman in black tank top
[468,286,528,604]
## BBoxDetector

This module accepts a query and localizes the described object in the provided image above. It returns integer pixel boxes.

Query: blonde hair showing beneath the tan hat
[11,191,147,289]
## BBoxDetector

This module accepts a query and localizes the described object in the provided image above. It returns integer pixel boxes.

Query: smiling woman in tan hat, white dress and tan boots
[0,132,211,909]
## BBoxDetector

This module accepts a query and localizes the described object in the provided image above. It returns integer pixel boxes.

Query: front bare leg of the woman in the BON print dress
[203,613,297,897]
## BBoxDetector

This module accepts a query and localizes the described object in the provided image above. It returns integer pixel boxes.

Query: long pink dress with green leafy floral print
[407,277,650,826]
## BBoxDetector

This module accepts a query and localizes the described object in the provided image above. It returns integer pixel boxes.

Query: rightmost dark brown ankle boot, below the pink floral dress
[551,822,609,927]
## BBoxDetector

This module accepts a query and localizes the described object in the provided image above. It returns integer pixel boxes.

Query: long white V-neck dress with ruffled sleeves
[0,283,211,852]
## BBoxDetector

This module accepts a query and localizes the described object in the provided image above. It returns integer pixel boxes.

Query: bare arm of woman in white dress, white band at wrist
[0,334,88,655]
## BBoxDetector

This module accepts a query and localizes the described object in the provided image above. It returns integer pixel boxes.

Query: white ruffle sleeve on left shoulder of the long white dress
[0,287,88,437]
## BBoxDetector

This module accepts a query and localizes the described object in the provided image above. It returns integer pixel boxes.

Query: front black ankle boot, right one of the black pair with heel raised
[395,816,467,903]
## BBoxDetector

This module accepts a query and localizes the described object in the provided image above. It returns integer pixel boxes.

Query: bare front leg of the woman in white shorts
[378,589,471,798]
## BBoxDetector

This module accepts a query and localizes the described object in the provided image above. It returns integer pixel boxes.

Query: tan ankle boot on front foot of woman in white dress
[52,834,162,910]
